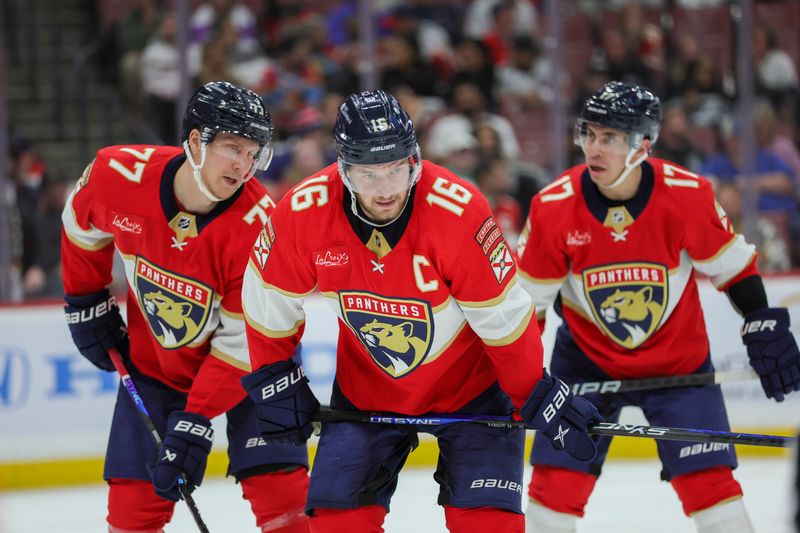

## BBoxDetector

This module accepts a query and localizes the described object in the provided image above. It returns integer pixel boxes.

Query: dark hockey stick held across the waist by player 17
[570,369,758,396]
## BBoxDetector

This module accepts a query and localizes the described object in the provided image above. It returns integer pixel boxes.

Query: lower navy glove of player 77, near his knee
[148,411,214,502]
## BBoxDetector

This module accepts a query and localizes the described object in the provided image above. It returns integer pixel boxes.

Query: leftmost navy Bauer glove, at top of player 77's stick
[64,289,128,372]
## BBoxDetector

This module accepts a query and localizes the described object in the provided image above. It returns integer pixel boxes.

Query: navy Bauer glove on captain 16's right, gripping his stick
[519,370,603,462]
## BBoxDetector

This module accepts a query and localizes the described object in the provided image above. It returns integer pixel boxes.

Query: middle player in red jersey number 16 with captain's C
[242,91,597,532]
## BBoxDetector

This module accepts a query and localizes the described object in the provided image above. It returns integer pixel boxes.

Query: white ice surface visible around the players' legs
[0,458,794,533]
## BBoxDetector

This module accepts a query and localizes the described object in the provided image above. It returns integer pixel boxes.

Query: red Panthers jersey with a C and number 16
[242,161,542,415]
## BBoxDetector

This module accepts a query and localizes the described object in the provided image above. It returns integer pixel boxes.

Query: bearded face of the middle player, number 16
[347,159,411,223]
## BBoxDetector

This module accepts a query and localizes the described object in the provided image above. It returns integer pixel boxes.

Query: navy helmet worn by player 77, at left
[182,81,273,158]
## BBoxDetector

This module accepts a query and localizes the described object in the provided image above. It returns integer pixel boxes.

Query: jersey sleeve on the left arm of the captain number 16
[242,202,317,370]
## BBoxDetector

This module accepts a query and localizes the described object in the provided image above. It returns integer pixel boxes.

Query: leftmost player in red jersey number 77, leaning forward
[62,82,308,533]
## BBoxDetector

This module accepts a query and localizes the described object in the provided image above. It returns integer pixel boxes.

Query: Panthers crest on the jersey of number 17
[582,263,668,350]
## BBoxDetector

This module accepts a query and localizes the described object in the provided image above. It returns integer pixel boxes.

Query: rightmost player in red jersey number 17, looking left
[518,82,800,533]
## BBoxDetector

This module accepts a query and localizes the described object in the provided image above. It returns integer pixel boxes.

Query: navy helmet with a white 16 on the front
[333,90,422,196]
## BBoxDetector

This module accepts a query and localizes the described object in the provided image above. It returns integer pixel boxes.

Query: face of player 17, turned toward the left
[580,124,630,186]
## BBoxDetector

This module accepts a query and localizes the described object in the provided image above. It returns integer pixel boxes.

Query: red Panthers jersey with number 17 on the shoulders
[517,158,757,378]
